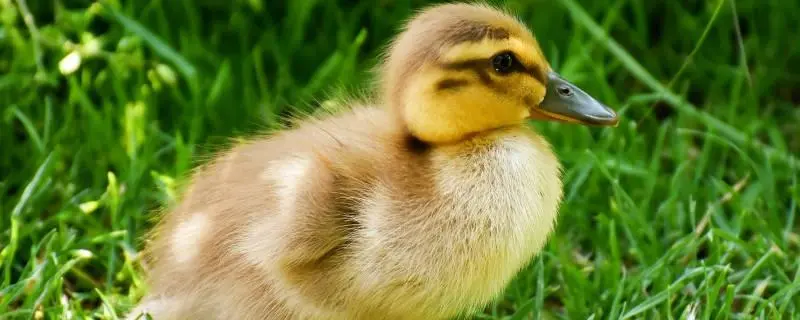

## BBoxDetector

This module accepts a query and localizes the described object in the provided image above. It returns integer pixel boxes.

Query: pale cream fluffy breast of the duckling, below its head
[356,128,562,318]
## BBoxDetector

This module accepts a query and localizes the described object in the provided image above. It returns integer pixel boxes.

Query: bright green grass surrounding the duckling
[0,0,800,319]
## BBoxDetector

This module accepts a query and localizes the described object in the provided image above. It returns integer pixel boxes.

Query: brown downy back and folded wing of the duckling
[129,107,396,319]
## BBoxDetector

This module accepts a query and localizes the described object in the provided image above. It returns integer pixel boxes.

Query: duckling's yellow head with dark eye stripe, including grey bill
[382,4,618,144]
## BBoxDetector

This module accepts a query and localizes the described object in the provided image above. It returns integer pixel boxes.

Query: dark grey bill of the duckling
[530,71,619,127]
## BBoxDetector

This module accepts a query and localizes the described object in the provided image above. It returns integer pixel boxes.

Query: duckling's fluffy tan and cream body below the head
[128,107,561,319]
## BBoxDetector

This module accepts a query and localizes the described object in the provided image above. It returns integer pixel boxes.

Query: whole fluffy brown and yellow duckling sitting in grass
[130,4,618,320]
